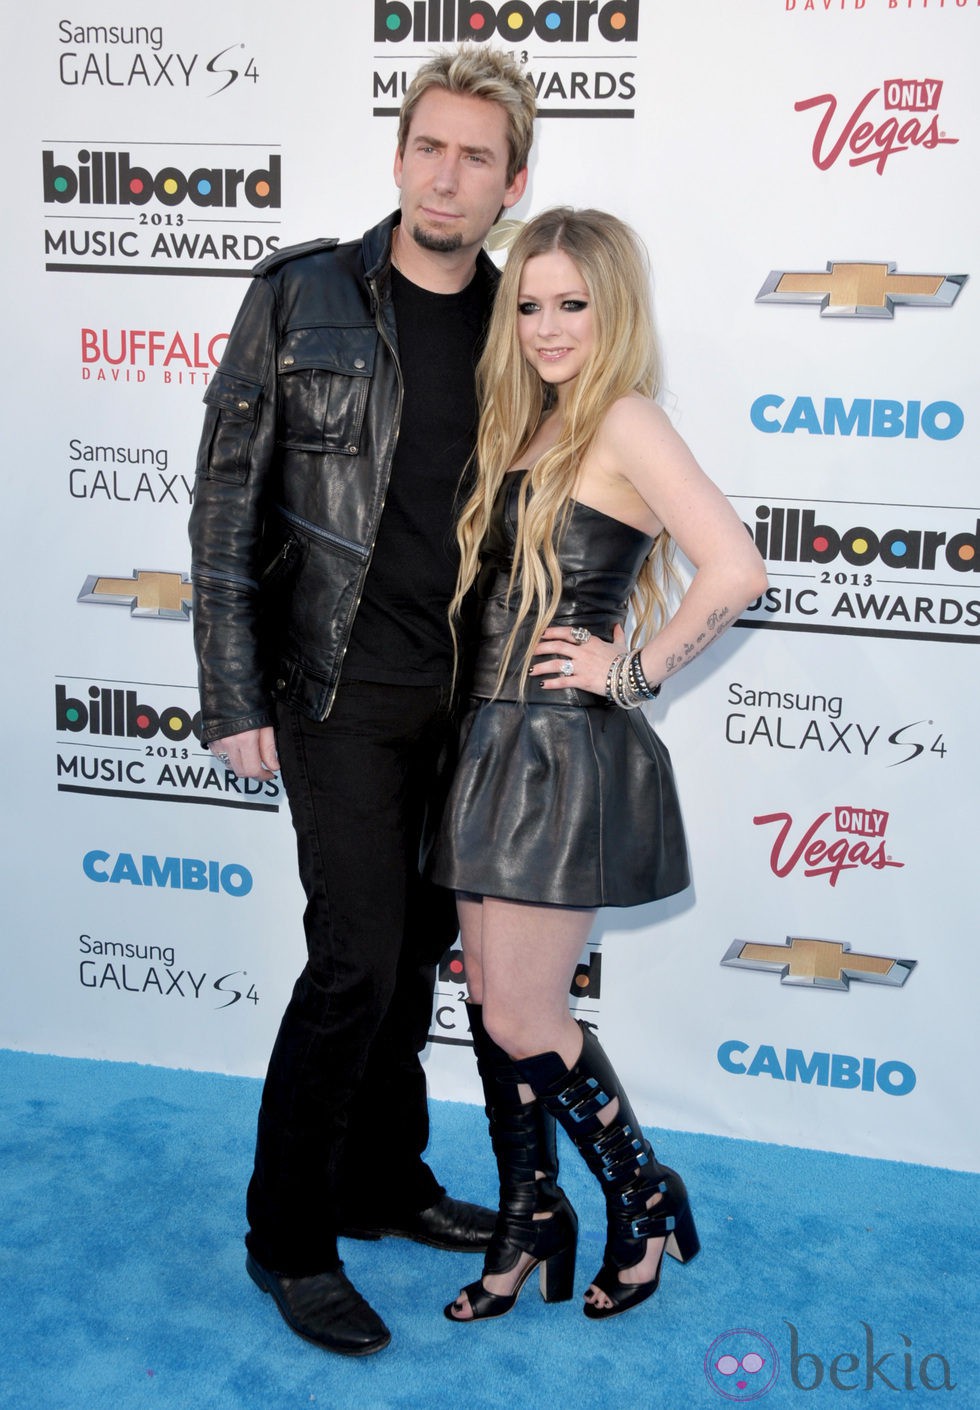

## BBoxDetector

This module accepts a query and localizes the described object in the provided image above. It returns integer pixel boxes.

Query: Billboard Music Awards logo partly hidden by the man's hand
[55,675,282,812]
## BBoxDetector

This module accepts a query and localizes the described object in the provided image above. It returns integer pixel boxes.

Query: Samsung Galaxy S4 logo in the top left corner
[56,20,261,97]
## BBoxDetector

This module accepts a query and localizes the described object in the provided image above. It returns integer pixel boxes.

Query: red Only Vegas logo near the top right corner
[794,78,959,176]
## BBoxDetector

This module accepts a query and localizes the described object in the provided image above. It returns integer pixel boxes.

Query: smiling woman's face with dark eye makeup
[517,250,595,400]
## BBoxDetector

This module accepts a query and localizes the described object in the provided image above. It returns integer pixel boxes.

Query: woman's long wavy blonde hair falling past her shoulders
[450,206,677,689]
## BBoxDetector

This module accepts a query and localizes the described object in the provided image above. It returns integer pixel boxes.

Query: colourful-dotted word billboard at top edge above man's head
[374,0,640,44]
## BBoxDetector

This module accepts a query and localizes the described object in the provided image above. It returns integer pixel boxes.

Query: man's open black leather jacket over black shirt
[190,213,498,744]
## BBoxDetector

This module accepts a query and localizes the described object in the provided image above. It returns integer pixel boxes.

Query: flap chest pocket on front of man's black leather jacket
[276,324,378,455]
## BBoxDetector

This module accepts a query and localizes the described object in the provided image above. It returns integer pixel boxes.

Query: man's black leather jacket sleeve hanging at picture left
[189,267,276,744]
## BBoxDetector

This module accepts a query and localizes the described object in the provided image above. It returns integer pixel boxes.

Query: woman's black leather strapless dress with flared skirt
[431,471,690,907]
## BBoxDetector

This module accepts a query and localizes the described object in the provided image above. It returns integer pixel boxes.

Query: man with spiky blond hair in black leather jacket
[184,47,534,1355]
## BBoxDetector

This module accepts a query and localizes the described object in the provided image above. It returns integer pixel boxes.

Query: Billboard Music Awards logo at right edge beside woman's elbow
[730,495,980,643]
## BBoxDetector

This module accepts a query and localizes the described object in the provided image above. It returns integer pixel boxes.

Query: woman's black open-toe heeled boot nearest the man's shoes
[446,1004,578,1321]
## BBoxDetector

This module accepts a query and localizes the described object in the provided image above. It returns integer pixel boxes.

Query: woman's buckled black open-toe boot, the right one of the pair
[515,1024,701,1318]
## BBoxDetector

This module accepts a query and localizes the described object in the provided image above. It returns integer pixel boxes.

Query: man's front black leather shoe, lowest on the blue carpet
[245,1253,392,1356]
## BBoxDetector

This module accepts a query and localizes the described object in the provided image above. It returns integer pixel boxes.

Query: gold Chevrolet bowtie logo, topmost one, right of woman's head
[756,262,969,319]
